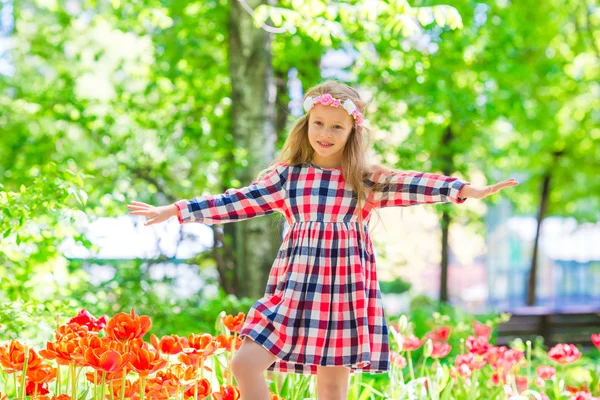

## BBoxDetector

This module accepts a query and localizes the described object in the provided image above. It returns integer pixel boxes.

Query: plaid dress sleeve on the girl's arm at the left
[175,163,288,225]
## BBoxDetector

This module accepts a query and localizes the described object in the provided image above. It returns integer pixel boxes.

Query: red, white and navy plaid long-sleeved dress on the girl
[176,163,469,374]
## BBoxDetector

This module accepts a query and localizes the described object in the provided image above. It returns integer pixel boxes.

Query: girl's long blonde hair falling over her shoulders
[257,80,402,238]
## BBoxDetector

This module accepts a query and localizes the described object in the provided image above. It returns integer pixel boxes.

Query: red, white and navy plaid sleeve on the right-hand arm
[366,171,471,208]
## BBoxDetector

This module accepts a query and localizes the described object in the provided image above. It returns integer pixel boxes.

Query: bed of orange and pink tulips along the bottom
[0,309,600,400]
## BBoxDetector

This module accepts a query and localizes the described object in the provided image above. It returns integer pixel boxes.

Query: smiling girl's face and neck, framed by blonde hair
[308,104,354,168]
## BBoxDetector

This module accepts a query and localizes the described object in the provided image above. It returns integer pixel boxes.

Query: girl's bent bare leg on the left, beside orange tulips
[231,336,277,400]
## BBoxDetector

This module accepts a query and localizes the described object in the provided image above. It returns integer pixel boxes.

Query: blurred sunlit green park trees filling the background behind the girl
[0,0,600,348]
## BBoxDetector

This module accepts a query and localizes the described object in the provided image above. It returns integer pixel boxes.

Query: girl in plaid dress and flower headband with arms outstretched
[128,81,518,400]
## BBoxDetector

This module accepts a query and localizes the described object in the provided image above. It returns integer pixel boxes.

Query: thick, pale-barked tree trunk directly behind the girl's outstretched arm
[223,0,281,298]
